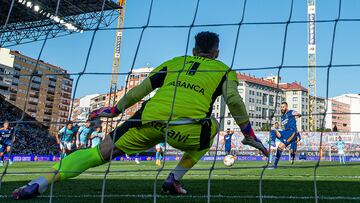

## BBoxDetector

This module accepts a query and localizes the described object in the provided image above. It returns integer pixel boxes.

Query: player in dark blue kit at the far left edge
[0,121,15,166]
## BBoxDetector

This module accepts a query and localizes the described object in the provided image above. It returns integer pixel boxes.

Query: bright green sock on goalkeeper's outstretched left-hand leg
[53,145,107,180]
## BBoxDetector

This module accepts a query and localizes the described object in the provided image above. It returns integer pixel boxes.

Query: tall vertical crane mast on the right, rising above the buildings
[307,0,317,131]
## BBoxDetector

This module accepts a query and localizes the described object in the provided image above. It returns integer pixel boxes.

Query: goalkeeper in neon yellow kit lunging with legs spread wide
[13,32,269,199]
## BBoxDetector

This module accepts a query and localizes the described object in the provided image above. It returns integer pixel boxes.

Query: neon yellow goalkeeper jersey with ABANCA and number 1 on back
[142,56,237,123]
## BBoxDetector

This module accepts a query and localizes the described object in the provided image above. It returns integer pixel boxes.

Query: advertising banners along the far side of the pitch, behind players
[7,132,360,162]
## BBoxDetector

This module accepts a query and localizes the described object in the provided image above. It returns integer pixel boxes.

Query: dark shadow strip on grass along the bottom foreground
[0,179,360,203]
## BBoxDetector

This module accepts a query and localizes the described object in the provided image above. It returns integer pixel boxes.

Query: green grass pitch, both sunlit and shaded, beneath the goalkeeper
[0,161,360,203]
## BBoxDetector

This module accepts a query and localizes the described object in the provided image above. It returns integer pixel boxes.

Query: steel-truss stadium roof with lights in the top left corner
[0,0,120,47]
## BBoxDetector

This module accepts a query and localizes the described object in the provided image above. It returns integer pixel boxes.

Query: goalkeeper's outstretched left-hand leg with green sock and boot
[13,136,122,199]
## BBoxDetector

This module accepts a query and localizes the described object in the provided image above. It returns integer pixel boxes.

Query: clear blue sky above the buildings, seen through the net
[7,0,360,97]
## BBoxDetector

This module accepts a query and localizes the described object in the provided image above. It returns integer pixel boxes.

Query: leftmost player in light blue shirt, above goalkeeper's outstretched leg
[56,122,75,158]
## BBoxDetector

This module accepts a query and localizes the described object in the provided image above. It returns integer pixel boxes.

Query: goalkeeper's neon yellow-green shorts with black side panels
[110,110,218,161]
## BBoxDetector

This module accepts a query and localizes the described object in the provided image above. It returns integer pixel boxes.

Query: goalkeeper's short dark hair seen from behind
[195,31,219,53]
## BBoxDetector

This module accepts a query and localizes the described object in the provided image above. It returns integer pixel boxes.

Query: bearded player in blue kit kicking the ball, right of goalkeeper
[270,102,301,168]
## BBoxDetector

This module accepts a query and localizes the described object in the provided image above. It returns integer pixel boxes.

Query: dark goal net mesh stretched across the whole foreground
[0,0,360,202]
